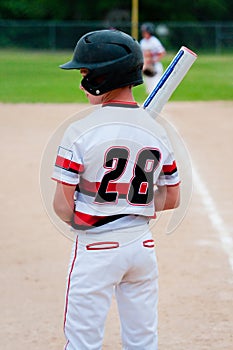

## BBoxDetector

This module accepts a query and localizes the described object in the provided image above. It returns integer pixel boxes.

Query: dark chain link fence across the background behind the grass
[0,20,233,53]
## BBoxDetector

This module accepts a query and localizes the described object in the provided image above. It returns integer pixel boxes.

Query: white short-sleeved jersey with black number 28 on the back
[52,102,179,231]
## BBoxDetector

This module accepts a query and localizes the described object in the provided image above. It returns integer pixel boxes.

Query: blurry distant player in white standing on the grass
[140,23,166,93]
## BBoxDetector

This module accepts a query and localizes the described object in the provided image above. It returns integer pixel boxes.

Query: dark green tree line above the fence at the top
[0,0,233,22]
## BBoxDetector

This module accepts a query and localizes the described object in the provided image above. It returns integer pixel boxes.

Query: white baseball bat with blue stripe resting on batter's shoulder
[143,46,197,117]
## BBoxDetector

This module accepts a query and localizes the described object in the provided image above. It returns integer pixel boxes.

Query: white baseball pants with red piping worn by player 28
[64,225,158,350]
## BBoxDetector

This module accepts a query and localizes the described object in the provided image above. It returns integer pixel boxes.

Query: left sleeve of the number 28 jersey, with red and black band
[52,126,84,185]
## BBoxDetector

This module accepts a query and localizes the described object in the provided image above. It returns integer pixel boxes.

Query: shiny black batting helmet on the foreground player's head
[60,29,143,95]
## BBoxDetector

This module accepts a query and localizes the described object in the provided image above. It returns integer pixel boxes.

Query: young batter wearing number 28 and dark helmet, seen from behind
[53,30,179,350]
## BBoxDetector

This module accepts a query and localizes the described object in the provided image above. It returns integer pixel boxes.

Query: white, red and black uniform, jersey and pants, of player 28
[52,102,179,350]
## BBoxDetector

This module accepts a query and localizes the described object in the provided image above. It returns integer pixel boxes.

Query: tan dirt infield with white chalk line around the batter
[0,102,233,350]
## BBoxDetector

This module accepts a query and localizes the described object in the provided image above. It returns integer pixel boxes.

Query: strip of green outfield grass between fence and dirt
[0,50,233,103]
